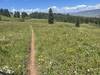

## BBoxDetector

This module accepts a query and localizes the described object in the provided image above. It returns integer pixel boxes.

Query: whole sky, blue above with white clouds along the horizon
[0,0,100,13]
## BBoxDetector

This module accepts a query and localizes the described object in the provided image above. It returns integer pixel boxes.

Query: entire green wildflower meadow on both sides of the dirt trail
[0,20,100,75]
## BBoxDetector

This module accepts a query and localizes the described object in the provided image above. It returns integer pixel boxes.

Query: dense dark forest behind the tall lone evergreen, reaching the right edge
[29,12,100,24]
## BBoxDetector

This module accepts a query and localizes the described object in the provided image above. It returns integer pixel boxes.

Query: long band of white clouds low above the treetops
[11,4,100,13]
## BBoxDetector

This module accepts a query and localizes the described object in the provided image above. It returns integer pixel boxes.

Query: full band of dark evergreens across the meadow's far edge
[0,8,100,24]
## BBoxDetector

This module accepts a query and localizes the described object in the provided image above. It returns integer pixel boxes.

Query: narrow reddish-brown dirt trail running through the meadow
[28,30,36,75]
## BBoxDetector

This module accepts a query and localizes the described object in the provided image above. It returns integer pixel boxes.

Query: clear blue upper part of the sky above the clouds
[0,0,100,9]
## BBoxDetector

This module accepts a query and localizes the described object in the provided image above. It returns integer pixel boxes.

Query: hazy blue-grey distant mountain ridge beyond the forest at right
[72,9,100,17]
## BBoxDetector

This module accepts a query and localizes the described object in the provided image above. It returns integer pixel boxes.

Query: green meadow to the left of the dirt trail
[0,21,30,75]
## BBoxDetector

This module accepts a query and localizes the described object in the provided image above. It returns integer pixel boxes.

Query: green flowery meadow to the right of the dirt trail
[33,22,100,75]
